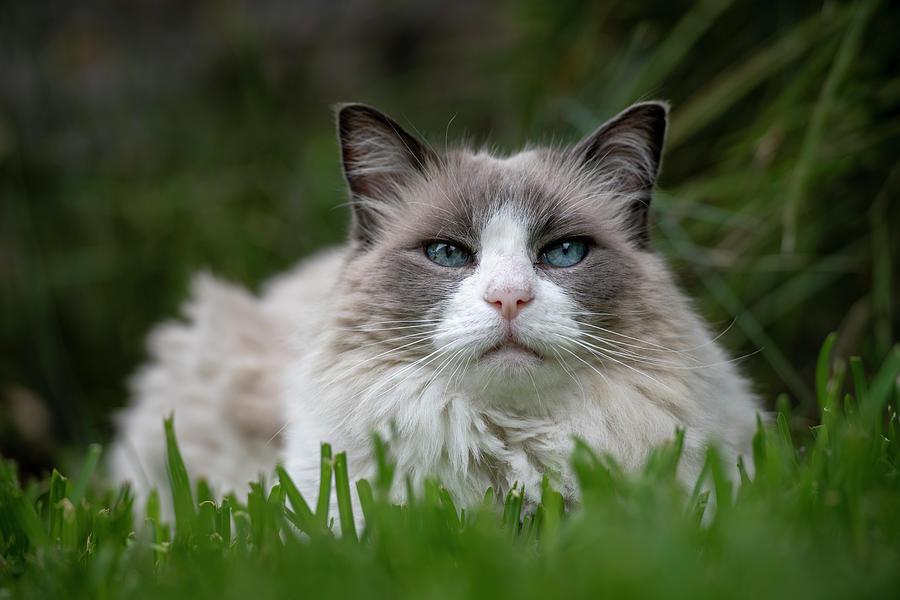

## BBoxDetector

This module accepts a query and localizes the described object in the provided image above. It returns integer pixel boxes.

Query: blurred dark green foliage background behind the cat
[0,0,900,470]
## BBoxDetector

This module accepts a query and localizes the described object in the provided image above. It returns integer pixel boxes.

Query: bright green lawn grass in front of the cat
[0,337,900,599]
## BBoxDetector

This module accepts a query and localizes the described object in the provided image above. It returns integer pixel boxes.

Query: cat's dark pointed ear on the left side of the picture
[338,104,437,245]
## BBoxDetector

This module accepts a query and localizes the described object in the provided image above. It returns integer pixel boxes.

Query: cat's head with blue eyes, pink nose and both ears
[330,102,667,394]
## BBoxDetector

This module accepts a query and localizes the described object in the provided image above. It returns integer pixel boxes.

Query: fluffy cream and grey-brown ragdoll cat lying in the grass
[113,102,758,520]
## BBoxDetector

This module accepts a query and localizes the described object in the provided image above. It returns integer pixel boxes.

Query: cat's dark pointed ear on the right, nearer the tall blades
[572,102,669,246]
